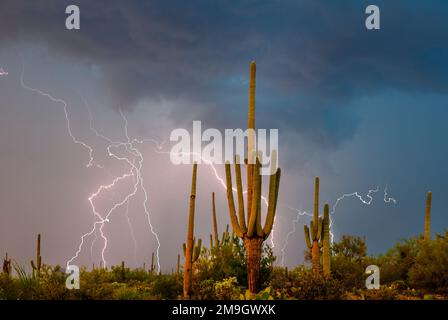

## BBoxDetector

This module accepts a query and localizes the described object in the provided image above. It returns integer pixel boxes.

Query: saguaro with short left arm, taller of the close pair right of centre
[304,177,323,274]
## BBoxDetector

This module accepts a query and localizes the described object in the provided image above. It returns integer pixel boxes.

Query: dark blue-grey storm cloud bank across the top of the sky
[0,0,448,149]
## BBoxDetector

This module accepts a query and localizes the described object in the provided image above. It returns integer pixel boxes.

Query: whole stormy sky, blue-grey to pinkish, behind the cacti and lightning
[0,0,448,271]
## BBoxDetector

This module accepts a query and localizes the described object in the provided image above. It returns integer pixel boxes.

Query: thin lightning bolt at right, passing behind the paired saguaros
[281,185,397,265]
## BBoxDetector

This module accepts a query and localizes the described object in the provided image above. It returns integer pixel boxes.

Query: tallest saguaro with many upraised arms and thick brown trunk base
[225,62,281,293]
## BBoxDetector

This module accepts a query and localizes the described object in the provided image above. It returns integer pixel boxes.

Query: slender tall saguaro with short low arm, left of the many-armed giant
[183,163,202,299]
